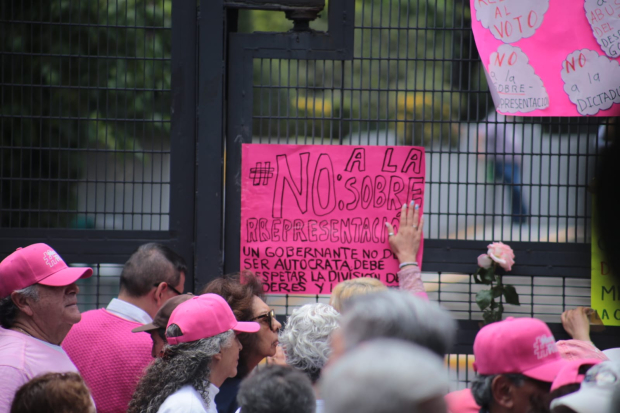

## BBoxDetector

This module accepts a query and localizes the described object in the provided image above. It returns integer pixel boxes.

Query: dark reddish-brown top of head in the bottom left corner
[11,373,95,413]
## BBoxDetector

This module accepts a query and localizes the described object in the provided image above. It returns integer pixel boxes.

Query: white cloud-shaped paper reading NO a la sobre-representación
[489,44,549,113]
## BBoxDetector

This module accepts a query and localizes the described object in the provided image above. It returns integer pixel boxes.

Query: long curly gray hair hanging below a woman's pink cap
[127,324,235,413]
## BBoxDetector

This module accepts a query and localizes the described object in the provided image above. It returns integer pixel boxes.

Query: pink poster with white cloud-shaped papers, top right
[471,0,620,116]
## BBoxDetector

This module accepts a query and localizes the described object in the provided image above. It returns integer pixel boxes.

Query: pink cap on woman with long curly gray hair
[166,294,260,345]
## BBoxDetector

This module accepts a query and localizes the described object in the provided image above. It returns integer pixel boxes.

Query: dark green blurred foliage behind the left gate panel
[0,0,172,228]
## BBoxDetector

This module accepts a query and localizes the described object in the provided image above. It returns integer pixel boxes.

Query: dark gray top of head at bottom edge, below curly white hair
[237,364,316,413]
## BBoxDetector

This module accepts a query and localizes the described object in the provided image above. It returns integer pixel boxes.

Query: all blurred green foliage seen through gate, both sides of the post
[0,0,486,228]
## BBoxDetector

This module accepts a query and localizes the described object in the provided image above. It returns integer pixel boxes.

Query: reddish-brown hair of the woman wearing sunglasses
[200,272,264,378]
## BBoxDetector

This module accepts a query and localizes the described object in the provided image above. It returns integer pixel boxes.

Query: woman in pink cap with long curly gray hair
[127,294,260,413]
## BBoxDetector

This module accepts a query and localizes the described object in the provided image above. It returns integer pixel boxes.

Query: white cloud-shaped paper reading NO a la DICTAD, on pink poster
[562,49,620,115]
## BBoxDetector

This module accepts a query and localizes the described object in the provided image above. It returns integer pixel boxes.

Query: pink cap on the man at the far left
[0,244,93,298]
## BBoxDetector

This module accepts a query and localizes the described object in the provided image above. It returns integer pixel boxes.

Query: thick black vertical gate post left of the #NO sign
[170,0,197,291]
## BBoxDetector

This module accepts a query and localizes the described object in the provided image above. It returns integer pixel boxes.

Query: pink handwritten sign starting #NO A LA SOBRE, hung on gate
[240,144,426,294]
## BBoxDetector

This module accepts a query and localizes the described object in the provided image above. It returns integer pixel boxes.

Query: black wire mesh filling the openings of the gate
[0,0,614,388]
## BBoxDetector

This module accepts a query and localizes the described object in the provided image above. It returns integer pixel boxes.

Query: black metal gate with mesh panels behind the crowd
[0,0,613,380]
